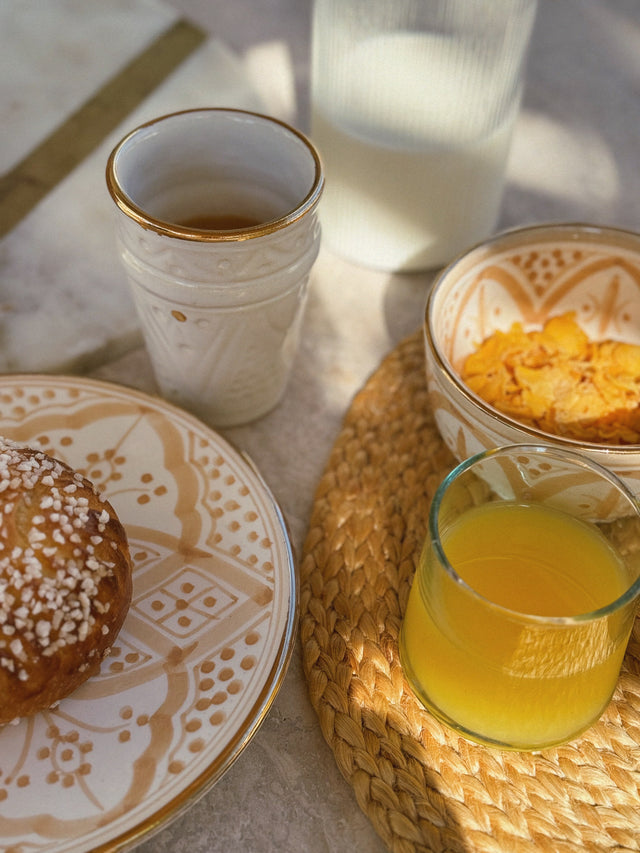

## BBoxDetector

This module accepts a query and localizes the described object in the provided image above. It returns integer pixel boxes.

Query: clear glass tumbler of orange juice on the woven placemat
[400,445,640,750]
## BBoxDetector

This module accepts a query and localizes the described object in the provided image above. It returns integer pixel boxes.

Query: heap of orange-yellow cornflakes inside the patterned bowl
[461,312,640,445]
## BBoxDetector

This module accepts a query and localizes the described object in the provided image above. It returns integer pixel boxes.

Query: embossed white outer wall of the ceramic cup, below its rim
[117,203,320,426]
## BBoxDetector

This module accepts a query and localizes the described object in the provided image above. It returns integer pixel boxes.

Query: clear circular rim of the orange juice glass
[418,444,640,627]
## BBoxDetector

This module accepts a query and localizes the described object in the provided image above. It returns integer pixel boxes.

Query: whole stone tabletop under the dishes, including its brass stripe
[5,0,640,853]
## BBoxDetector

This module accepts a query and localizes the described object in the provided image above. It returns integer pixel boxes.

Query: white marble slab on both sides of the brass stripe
[0,0,269,373]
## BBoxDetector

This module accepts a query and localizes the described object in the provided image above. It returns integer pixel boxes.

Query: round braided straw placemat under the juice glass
[301,333,640,853]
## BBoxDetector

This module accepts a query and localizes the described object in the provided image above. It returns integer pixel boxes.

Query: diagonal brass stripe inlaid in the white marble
[0,20,205,237]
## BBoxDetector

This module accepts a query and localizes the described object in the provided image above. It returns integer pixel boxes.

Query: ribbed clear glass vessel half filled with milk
[311,0,536,270]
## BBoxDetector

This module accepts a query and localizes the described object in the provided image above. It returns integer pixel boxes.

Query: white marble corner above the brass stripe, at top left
[0,0,179,171]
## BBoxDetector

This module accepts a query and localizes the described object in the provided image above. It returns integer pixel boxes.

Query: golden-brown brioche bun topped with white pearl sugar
[0,438,132,724]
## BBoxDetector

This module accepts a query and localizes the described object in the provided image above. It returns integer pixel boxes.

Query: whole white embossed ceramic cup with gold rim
[107,109,324,427]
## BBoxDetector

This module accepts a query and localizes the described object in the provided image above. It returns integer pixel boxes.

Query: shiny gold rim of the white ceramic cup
[106,107,324,243]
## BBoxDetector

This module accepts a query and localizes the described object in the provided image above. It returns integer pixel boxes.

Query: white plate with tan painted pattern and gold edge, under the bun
[0,376,298,853]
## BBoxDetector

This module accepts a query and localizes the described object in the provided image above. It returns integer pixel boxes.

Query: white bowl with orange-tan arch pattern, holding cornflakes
[424,224,640,496]
